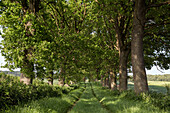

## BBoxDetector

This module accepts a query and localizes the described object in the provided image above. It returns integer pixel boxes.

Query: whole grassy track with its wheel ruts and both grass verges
[0,83,170,113]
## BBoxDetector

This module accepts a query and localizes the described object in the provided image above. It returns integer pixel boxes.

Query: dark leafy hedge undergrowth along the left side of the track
[0,74,78,108]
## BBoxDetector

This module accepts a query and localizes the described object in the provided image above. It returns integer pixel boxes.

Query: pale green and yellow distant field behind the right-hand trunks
[128,81,170,94]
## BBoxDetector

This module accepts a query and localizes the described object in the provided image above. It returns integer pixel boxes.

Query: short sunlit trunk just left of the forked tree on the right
[109,71,117,90]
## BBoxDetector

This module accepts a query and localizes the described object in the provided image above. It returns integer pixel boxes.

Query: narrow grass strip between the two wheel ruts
[69,84,109,113]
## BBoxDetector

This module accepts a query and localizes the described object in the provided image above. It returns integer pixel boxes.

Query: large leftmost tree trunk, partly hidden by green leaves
[21,0,40,84]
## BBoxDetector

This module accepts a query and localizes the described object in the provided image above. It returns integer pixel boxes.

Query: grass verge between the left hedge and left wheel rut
[2,82,84,113]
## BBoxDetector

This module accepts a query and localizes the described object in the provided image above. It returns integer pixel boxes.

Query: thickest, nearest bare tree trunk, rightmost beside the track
[131,0,148,94]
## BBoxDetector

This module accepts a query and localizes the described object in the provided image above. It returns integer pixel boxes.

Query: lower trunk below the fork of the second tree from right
[119,50,129,91]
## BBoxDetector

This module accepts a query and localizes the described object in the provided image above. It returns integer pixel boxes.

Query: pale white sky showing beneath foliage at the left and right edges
[0,29,170,75]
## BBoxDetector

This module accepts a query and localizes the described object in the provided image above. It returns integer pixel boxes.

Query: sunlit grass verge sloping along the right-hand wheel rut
[93,82,168,113]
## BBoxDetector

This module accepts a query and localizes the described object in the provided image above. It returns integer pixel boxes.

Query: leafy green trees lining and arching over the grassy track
[0,0,170,94]
